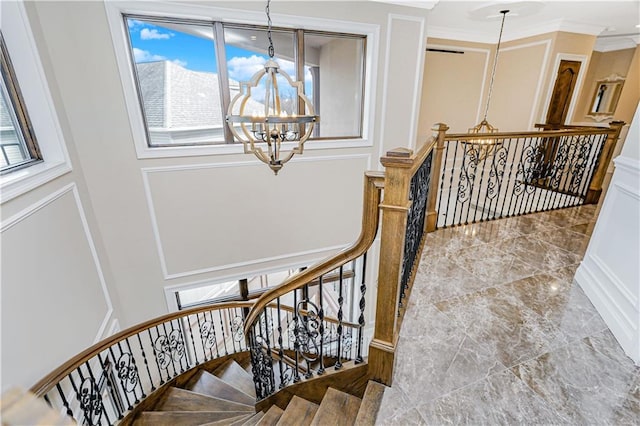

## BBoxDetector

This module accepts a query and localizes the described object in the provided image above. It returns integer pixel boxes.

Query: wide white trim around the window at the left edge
[0,2,72,203]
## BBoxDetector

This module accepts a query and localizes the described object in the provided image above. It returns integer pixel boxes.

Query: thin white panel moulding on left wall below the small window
[0,182,113,343]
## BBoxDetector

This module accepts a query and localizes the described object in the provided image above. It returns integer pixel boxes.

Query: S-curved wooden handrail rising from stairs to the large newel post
[244,172,384,337]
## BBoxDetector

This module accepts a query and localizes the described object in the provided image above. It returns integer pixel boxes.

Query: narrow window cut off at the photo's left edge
[0,33,42,174]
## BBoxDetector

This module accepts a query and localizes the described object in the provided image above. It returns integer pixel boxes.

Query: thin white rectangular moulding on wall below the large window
[140,154,371,280]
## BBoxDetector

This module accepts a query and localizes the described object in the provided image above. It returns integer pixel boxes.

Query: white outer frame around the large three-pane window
[104,1,380,159]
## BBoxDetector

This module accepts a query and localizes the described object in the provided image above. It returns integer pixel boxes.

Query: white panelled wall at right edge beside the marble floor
[575,101,640,364]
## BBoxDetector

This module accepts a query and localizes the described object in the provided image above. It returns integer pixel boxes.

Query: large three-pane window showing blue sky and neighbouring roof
[123,14,366,147]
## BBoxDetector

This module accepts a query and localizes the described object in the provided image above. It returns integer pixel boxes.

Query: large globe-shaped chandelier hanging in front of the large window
[226,0,320,175]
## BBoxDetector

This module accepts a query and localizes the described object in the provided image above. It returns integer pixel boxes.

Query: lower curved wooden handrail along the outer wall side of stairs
[30,301,254,397]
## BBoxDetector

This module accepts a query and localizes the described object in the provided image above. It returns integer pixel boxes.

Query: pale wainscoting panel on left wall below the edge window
[0,184,113,387]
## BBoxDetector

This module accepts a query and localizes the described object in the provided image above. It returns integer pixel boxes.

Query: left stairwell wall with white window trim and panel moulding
[0,2,119,391]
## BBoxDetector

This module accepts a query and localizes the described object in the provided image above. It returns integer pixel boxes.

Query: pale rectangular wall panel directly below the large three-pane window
[142,154,370,279]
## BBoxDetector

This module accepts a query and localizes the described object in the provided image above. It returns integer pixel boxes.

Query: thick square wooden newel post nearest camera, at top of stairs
[369,148,413,386]
